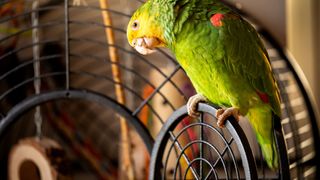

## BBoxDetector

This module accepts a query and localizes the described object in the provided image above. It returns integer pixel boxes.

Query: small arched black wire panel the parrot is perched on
[149,104,258,179]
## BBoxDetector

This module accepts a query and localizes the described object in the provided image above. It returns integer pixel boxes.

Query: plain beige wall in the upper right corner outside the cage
[286,0,320,109]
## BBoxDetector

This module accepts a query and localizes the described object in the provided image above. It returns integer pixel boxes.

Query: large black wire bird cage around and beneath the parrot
[0,0,320,179]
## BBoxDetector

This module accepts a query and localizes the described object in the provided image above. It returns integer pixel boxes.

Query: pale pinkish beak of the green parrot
[132,37,161,55]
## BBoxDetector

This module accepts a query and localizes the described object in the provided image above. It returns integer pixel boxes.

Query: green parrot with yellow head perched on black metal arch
[127,0,281,169]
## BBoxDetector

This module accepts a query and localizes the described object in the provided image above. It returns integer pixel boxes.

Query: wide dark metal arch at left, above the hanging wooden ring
[0,90,154,153]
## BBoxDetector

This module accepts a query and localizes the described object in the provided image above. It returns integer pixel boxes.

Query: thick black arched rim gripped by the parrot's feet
[149,103,258,180]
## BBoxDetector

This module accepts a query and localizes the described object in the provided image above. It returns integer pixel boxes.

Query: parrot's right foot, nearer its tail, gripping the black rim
[216,107,240,128]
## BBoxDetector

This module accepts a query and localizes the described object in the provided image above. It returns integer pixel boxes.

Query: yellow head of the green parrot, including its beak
[127,1,166,55]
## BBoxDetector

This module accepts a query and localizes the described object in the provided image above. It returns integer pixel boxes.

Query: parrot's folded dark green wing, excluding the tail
[221,15,281,117]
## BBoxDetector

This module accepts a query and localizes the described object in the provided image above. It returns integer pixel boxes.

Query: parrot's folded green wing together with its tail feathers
[221,11,281,169]
